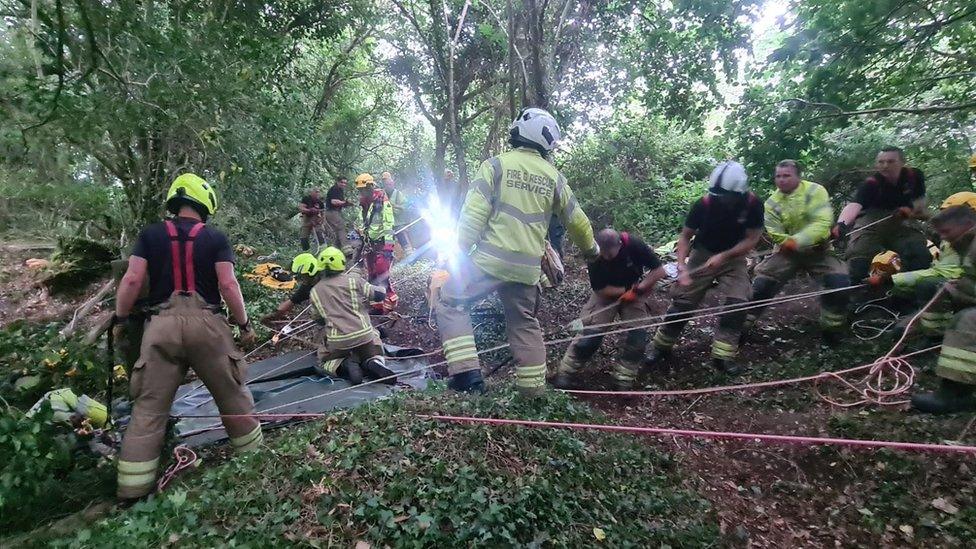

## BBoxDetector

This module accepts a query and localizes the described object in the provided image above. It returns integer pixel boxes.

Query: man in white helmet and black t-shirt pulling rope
[646,160,763,375]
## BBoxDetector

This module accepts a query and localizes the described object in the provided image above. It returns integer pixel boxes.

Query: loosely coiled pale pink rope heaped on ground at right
[814,287,944,408]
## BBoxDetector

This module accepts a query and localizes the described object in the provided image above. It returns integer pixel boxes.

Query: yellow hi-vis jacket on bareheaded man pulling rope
[766,181,834,248]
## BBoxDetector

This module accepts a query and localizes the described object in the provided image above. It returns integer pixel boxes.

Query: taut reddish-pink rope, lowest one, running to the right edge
[418,415,976,454]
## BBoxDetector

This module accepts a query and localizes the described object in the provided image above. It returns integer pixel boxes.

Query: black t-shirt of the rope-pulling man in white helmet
[685,193,765,253]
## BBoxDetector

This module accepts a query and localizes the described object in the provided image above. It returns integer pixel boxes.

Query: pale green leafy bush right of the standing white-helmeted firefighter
[561,116,715,244]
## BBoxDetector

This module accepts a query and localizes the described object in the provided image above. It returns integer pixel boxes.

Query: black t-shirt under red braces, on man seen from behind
[132,217,234,306]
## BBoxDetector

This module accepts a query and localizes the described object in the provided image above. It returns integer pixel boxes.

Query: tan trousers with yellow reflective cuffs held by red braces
[118,293,263,498]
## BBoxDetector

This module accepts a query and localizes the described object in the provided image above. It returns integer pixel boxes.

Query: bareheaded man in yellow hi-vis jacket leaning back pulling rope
[746,160,851,342]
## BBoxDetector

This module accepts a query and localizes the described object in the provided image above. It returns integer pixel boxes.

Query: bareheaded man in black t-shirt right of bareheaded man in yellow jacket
[831,147,932,292]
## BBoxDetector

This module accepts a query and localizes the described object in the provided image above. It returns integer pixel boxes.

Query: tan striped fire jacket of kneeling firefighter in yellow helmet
[311,271,378,351]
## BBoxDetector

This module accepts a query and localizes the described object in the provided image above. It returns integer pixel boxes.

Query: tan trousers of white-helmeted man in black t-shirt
[654,249,752,360]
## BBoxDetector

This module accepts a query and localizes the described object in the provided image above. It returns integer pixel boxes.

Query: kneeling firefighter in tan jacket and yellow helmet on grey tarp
[311,246,395,385]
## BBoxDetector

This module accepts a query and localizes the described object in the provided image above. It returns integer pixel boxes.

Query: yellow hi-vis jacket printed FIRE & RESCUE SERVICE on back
[458,148,597,284]
